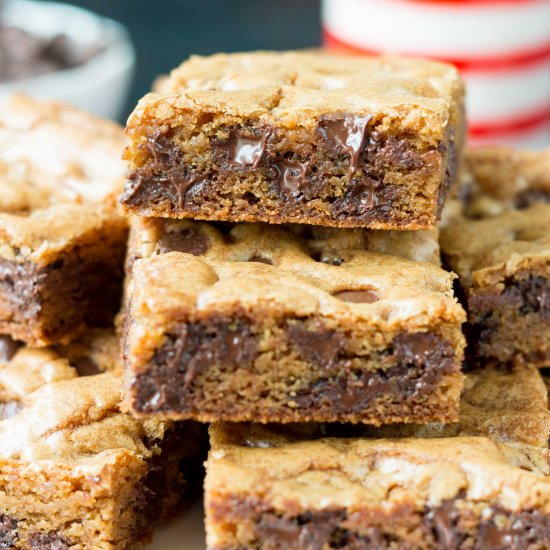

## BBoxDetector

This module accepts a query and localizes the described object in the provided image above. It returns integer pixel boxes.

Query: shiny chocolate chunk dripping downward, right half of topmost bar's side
[317,115,371,177]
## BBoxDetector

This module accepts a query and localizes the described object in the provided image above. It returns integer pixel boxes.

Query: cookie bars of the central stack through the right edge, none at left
[121,52,550,550]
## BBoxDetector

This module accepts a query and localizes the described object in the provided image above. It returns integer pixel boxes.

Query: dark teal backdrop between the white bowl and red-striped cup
[67,0,321,114]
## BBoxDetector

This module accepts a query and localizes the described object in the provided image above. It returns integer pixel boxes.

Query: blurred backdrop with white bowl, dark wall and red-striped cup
[0,0,550,148]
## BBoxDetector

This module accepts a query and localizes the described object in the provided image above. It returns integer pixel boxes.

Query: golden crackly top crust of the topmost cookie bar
[129,51,462,139]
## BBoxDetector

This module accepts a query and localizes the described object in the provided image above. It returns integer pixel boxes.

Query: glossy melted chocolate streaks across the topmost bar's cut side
[122,114,418,217]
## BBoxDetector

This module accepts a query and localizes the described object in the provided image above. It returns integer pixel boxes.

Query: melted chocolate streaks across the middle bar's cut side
[132,317,458,414]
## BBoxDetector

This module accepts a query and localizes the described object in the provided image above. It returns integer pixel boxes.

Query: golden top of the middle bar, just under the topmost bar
[130,219,463,326]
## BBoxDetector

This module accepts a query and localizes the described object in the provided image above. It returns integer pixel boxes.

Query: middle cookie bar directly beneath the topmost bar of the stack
[123,219,464,425]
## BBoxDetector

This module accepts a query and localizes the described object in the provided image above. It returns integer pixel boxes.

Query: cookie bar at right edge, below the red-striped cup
[441,149,550,367]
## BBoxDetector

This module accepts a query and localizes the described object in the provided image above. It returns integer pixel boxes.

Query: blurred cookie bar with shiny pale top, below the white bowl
[0,97,127,346]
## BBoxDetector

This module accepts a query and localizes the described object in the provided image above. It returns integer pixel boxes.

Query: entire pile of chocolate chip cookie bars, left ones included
[0,52,550,550]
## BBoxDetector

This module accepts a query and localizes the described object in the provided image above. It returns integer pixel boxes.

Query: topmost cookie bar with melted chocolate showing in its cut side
[121,52,464,229]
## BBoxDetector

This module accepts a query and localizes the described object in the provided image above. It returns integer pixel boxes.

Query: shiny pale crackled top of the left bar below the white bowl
[0,96,125,261]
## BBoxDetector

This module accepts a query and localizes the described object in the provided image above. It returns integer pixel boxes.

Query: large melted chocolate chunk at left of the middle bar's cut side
[134,317,259,412]
